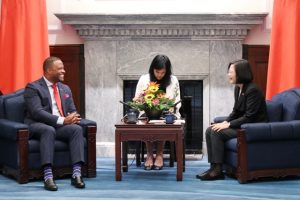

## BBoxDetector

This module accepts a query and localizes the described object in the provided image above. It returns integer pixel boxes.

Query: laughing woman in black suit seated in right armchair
[196,60,268,180]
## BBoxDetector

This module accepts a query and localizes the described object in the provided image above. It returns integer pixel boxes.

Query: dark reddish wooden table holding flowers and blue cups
[115,123,184,181]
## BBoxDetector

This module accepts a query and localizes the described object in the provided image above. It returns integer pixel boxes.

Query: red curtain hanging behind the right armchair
[266,0,300,99]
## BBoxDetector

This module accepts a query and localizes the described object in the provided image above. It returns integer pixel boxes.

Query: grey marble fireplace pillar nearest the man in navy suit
[84,41,122,156]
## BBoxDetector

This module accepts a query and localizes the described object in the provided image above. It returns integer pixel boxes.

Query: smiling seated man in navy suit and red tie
[24,57,85,191]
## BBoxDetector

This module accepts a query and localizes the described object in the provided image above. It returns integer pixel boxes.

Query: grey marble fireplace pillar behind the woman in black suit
[202,40,242,154]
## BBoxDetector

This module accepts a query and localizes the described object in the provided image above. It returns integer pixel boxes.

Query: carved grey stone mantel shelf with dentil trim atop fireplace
[56,13,267,40]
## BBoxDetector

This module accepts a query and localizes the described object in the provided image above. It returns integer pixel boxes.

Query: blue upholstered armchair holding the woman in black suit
[215,88,300,183]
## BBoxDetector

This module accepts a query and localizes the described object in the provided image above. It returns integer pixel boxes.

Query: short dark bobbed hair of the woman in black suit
[228,59,253,84]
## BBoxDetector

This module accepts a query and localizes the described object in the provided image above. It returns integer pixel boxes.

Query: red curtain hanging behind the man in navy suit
[0,0,49,94]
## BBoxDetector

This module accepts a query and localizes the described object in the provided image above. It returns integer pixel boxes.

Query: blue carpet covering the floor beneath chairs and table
[0,158,300,200]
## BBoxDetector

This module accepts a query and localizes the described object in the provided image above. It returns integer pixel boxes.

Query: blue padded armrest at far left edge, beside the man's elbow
[0,119,29,141]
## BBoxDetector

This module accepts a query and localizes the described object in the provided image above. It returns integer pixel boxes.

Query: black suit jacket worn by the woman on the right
[226,83,268,128]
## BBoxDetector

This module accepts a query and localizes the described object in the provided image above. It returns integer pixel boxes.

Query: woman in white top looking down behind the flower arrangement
[135,55,181,170]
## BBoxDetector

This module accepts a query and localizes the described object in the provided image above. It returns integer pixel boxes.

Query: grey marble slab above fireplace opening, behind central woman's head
[117,40,209,76]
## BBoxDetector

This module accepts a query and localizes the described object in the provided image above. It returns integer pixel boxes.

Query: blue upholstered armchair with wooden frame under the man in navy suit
[0,89,97,183]
